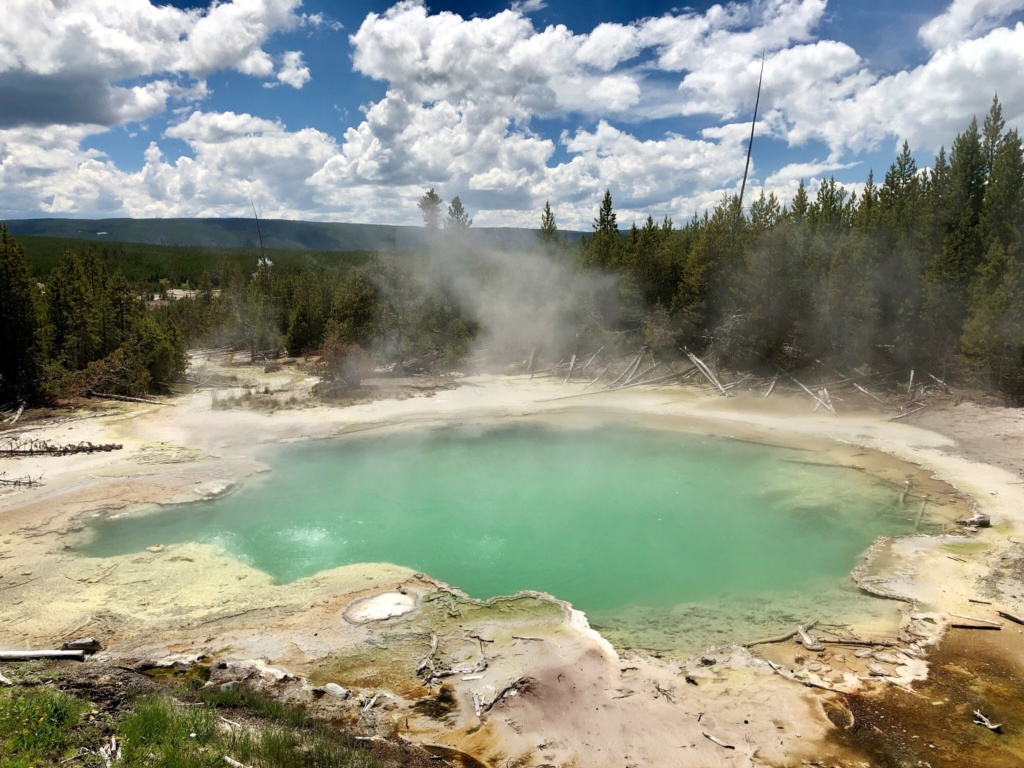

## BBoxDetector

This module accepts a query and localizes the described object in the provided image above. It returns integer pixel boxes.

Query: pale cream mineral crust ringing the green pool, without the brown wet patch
[0,362,1024,768]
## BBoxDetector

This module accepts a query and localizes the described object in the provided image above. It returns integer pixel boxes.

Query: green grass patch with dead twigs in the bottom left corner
[0,685,394,768]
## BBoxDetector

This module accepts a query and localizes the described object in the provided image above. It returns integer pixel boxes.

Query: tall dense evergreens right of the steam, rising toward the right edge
[573,98,1024,402]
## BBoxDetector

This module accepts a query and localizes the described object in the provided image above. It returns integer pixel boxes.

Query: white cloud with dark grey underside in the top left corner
[0,0,309,127]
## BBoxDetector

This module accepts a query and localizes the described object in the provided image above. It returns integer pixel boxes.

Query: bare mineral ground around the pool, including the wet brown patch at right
[0,357,1024,768]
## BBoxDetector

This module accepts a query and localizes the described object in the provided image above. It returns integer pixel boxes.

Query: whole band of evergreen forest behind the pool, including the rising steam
[0,99,1024,406]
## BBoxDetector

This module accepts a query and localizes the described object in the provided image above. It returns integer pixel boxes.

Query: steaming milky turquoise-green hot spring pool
[83,424,929,652]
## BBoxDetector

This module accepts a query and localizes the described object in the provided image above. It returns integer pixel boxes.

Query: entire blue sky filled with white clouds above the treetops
[0,0,1024,228]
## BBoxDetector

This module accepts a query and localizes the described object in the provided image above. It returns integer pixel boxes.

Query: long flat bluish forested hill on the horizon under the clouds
[6,218,583,251]
